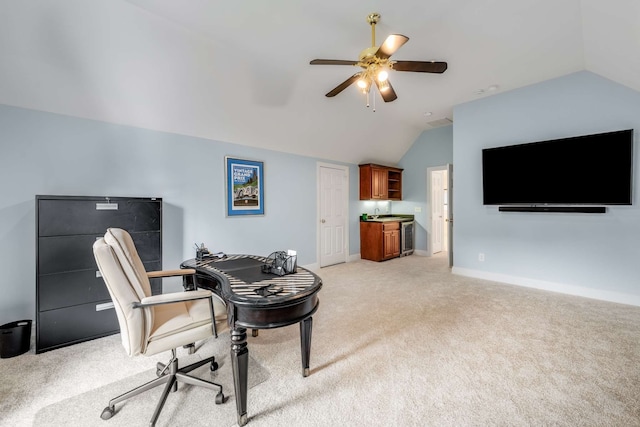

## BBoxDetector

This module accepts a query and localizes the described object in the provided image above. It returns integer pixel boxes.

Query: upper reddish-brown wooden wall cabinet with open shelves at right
[360,163,402,200]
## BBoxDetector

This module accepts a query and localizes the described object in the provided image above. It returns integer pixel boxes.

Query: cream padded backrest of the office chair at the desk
[93,228,153,356]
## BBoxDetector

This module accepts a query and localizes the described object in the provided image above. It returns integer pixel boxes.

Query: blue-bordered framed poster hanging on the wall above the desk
[225,157,264,216]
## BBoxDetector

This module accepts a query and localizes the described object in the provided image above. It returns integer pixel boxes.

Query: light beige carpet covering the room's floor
[0,256,640,427]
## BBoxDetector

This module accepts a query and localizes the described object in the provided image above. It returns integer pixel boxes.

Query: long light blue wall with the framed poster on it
[0,105,360,323]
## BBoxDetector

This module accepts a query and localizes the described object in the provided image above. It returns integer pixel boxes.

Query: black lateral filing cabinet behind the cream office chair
[36,196,162,353]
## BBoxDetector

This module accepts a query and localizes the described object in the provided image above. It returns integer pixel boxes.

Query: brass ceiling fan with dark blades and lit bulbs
[310,12,447,106]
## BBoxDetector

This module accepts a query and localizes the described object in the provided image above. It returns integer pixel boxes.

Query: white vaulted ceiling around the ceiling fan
[0,0,640,164]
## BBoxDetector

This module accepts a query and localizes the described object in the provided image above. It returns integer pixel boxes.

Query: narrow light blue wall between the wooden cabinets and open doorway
[392,126,455,251]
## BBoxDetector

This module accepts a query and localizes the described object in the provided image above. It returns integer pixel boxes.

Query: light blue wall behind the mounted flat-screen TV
[453,72,640,305]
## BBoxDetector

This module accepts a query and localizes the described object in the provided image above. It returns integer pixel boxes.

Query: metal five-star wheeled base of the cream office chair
[100,349,224,426]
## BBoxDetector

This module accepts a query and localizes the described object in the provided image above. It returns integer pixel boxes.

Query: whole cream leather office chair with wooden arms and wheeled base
[93,228,227,425]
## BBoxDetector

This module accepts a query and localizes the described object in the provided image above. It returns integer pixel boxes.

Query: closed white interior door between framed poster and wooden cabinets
[318,165,349,267]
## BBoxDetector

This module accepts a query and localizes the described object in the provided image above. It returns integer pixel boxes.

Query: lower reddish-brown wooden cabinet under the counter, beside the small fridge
[360,221,400,261]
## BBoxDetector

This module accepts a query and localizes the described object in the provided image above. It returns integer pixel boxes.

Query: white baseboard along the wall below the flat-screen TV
[451,267,640,306]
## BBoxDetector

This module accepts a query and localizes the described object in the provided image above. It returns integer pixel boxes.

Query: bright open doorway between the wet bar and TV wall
[427,164,453,267]
